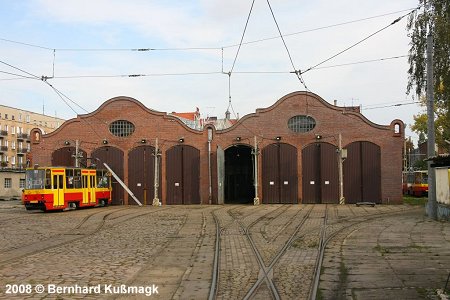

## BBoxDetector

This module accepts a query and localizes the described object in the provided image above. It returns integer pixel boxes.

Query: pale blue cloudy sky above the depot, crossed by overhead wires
[0,0,424,140]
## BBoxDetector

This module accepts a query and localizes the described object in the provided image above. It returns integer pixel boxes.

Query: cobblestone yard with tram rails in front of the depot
[0,201,450,299]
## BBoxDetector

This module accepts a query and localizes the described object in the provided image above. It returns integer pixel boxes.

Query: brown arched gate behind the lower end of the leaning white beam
[128,146,161,205]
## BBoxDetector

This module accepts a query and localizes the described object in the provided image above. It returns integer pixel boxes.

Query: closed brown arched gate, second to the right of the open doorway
[302,143,339,203]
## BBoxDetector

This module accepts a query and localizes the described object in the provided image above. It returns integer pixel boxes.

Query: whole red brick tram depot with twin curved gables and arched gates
[31,92,404,205]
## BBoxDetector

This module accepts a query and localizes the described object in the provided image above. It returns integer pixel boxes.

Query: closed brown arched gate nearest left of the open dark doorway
[166,145,200,204]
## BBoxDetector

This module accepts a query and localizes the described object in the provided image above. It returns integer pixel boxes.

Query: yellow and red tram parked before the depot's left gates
[22,167,112,211]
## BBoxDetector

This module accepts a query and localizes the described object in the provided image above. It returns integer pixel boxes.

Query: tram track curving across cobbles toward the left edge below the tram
[0,208,169,267]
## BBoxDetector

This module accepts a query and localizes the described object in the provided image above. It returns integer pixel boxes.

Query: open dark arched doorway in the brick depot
[225,145,255,204]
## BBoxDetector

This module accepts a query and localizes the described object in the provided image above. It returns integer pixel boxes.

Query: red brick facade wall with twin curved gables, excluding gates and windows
[31,92,404,204]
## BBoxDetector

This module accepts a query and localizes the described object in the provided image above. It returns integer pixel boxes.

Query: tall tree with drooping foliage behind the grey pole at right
[407,0,450,147]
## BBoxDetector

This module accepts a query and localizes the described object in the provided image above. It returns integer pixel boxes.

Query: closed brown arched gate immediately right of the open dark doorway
[262,143,298,204]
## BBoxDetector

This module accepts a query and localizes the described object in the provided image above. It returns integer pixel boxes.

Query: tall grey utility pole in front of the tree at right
[427,32,437,220]
